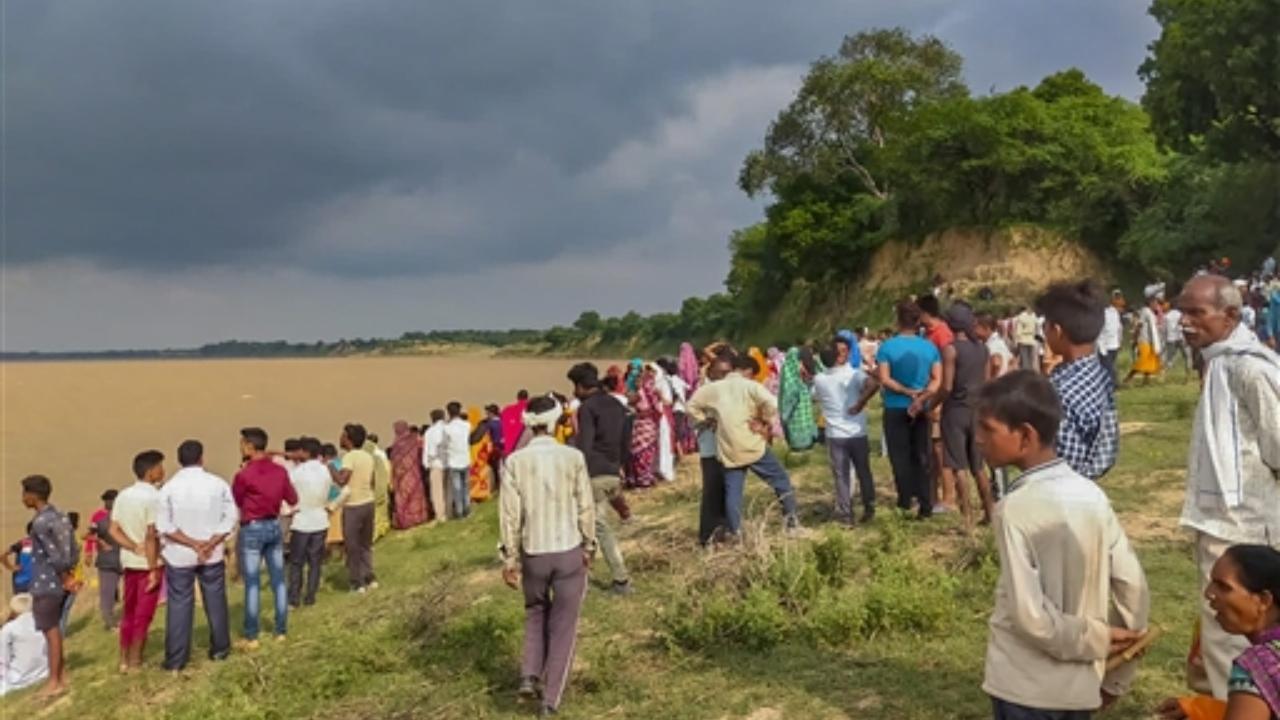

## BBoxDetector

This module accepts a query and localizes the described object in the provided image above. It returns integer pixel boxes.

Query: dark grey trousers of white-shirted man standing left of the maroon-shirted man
[164,562,232,670]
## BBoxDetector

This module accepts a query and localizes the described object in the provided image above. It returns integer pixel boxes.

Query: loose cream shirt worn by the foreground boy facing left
[983,460,1149,710]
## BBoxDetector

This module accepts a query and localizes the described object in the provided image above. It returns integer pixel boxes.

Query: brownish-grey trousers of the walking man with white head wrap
[520,547,586,708]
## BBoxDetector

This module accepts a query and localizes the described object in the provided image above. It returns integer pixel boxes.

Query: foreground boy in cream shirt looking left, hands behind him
[978,370,1149,720]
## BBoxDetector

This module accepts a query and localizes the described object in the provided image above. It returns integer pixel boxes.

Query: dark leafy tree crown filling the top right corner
[1138,0,1280,161]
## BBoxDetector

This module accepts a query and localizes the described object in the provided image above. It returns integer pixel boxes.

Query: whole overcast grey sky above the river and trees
[0,0,1157,351]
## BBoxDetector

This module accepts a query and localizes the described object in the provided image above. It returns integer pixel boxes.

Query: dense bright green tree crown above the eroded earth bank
[888,69,1165,249]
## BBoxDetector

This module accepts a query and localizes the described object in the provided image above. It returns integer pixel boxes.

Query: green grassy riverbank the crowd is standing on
[15,384,1197,720]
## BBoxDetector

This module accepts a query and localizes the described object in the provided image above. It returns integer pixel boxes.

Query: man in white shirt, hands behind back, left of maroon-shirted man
[156,439,239,670]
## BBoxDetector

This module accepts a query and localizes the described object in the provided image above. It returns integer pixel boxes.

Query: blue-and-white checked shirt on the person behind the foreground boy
[1048,354,1120,480]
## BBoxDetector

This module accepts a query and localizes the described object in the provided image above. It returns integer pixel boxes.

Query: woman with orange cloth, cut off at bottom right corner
[1158,544,1280,720]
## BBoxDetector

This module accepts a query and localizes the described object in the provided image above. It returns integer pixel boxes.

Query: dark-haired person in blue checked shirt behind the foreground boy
[1036,281,1120,480]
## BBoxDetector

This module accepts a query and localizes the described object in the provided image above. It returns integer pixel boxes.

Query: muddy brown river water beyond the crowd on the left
[0,355,599,545]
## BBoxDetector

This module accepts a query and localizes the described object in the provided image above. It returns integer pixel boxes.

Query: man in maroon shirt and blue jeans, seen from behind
[232,428,298,650]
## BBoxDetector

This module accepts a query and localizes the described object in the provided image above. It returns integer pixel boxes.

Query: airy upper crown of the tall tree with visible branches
[739,28,968,200]
